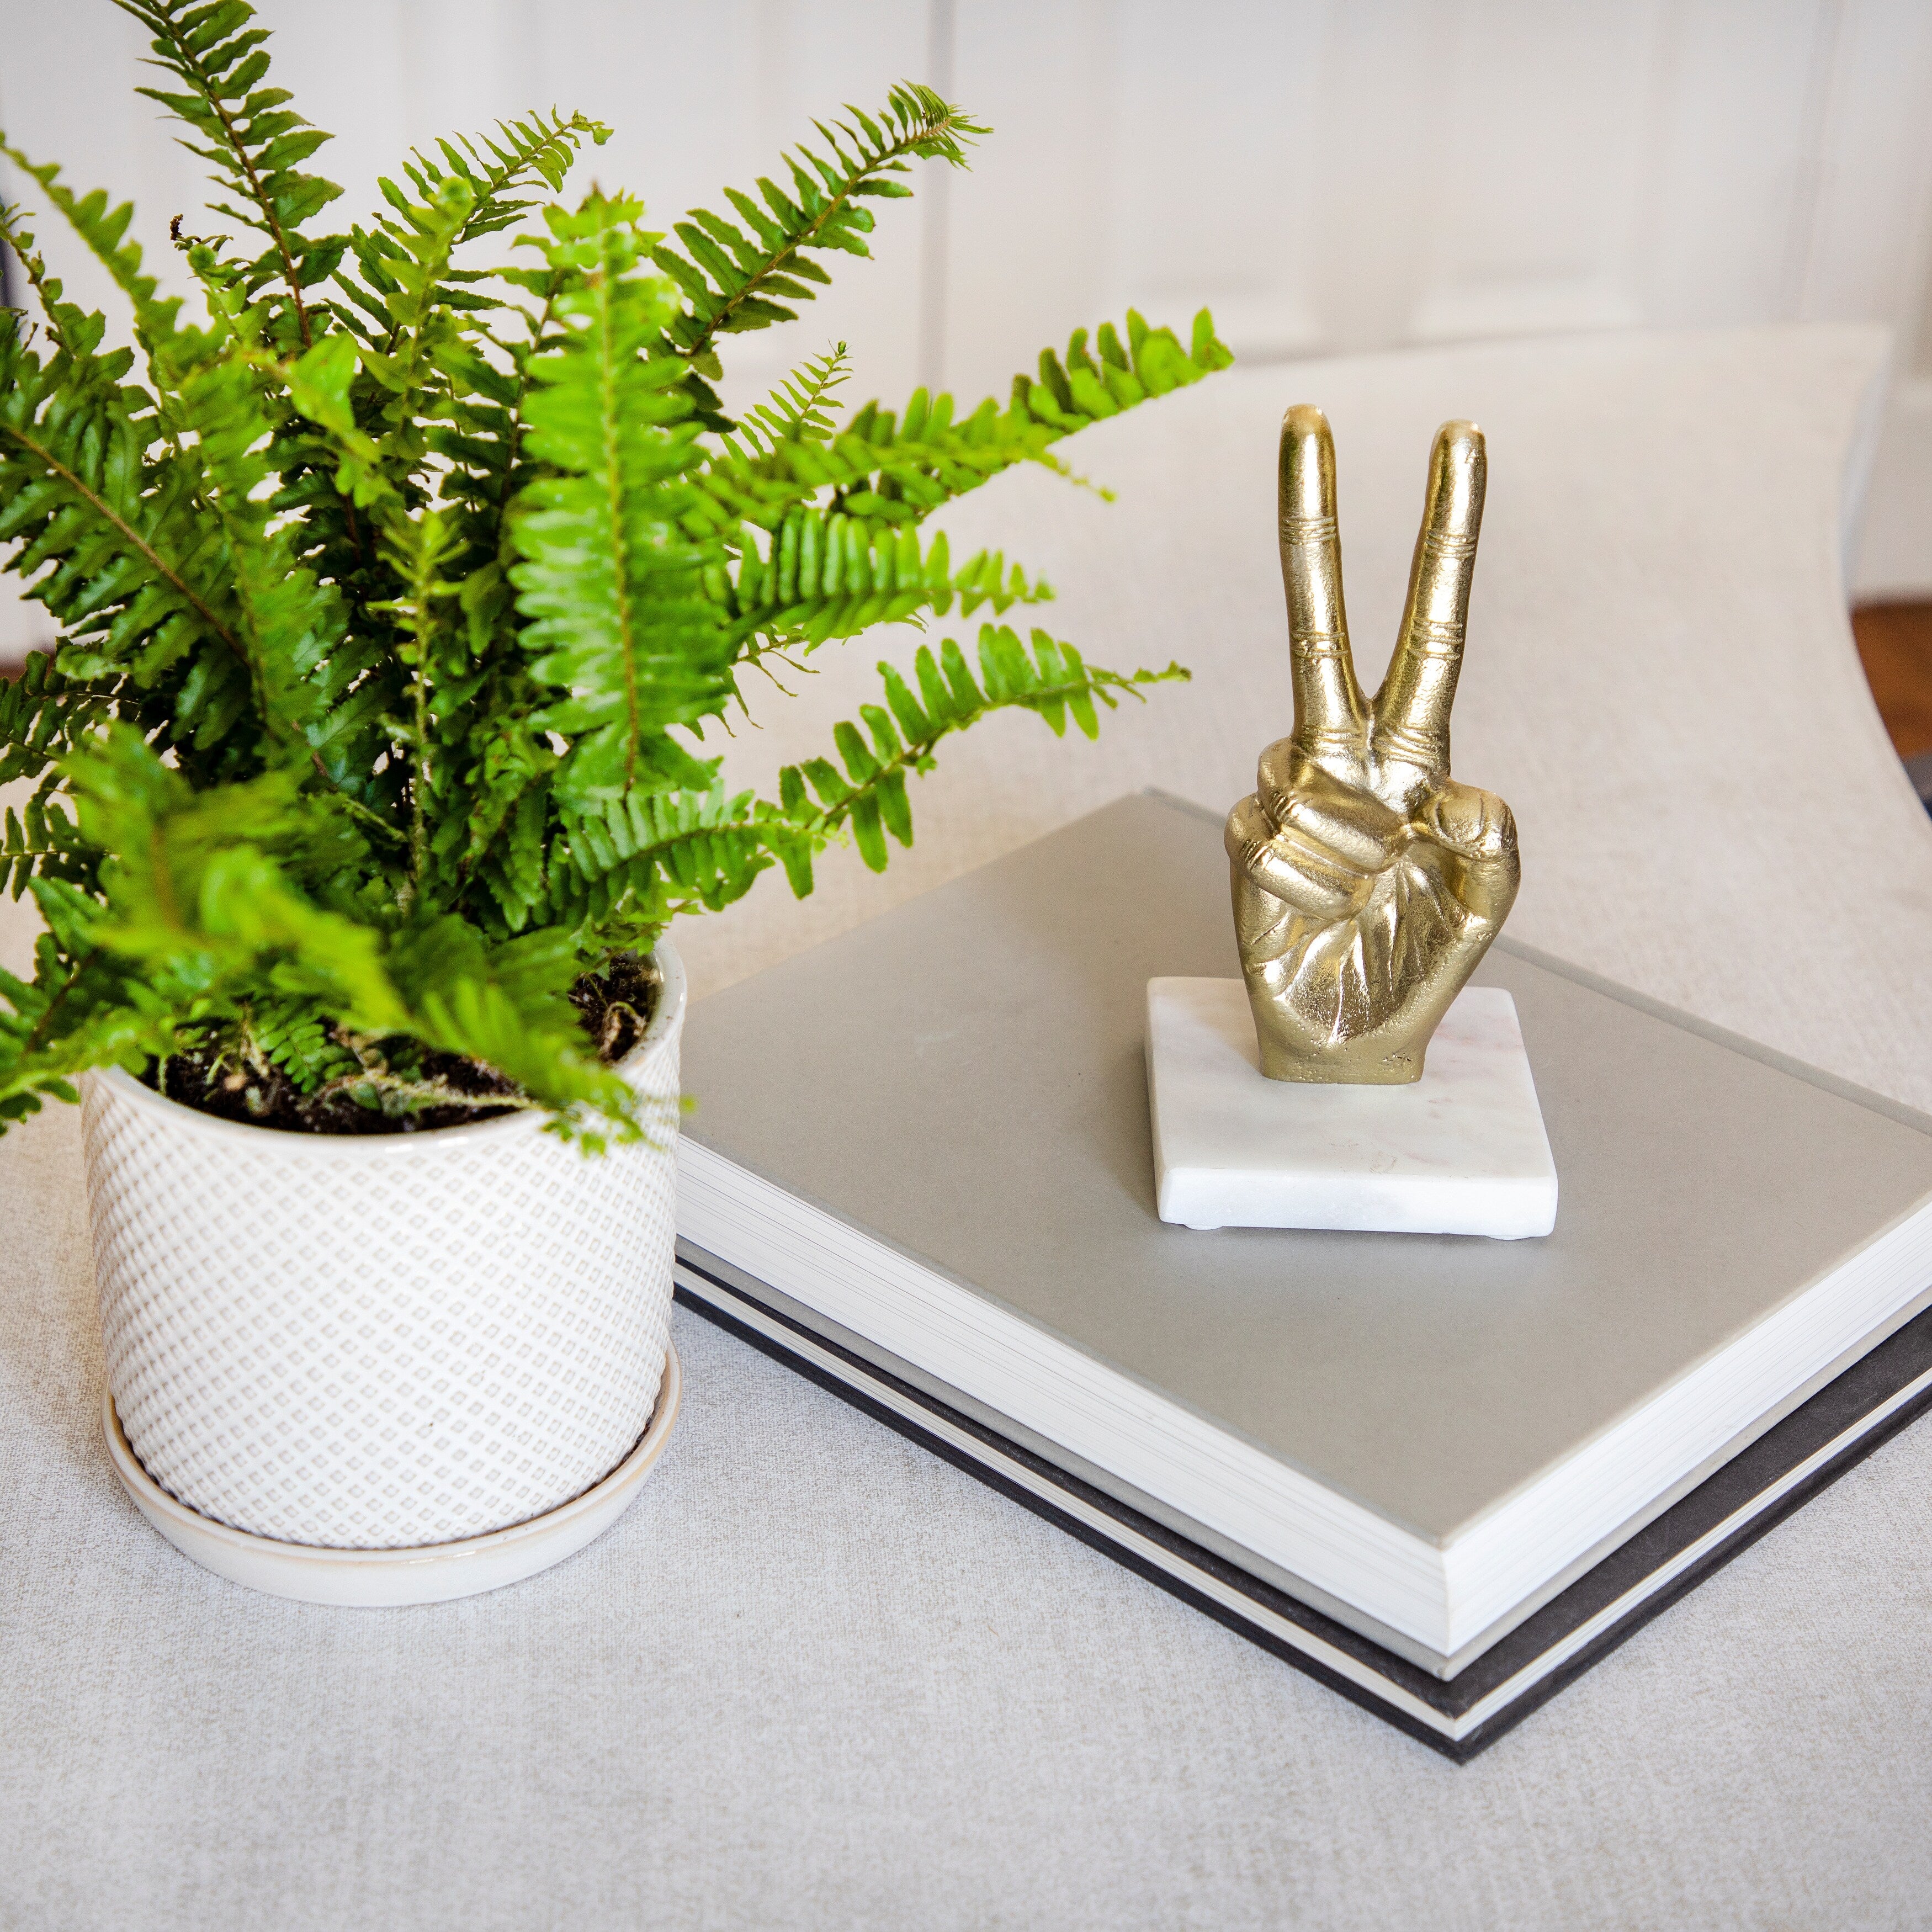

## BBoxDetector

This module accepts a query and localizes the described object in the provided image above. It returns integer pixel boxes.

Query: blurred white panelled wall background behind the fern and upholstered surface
[11,0,1932,790]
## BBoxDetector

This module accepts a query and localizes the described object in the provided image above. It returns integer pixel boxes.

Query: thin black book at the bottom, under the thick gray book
[676,1240,1932,1764]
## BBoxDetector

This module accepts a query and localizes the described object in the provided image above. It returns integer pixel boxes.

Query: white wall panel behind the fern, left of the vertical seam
[0,0,927,389]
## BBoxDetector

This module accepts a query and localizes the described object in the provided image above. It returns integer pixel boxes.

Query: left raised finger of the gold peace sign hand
[1279,402,1368,756]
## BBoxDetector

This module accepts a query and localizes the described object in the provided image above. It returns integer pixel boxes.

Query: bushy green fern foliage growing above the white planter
[0,45,1227,1146]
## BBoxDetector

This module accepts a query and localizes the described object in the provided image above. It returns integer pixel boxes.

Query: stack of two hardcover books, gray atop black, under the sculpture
[678,794,1932,1758]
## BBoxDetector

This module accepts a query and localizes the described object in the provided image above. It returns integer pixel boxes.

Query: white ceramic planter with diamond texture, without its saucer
[83,943,686,1577]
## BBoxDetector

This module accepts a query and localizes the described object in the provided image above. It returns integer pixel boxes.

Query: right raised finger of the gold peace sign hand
[1372,423,1488,777]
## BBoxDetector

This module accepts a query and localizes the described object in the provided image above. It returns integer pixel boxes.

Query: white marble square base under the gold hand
[1148,980,1557,1240]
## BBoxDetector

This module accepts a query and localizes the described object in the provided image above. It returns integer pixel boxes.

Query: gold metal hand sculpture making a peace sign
[1227,404,1521,1086]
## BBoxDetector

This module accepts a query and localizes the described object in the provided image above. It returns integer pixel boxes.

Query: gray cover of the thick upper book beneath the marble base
[680,796,1932,1673]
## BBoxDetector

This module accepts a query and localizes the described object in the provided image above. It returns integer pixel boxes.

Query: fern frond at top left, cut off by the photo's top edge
[114,0,342,348]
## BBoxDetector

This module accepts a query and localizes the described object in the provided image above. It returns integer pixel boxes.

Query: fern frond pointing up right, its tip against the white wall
[651,81,989,359]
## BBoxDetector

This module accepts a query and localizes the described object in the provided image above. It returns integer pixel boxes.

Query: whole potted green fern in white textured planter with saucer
[0,0,1229,1602]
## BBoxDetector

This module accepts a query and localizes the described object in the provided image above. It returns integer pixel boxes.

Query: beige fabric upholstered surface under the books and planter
[0,328,1932,1932]
